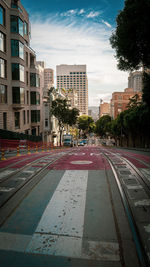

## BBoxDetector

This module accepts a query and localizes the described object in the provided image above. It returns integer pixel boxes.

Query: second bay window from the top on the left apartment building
[11,40,24,59]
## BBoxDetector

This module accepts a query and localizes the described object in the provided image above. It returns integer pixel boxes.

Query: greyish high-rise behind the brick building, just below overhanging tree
[128,71,143,92]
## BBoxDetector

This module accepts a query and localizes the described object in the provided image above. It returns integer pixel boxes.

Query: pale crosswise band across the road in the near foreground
[0,232,120,261]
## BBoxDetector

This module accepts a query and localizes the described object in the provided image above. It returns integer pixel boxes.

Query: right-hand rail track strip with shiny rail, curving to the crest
[104,151,150,267]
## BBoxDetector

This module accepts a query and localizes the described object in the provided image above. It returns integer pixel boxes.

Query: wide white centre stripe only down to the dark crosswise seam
[35,170,88,237]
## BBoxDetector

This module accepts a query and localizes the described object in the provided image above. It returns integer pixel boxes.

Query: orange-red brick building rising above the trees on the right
[110,88,141,119]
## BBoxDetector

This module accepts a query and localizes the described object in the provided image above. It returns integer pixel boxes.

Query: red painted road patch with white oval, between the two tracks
[48,147,110,170]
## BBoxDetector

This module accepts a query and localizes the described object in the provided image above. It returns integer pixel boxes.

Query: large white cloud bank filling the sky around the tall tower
[31,15,128,106]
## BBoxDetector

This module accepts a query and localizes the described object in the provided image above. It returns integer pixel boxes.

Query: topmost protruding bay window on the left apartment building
[10,16,23,36]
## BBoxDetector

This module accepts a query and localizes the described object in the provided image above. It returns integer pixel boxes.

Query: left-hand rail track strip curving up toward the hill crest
[0,151,69,225]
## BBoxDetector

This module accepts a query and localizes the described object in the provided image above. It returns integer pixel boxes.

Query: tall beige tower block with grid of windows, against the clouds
[56,65,88,115]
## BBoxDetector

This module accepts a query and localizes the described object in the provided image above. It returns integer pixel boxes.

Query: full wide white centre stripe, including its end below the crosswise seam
[27,170,88,257]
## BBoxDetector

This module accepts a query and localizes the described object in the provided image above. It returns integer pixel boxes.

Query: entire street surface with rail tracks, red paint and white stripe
[0,145,150,267]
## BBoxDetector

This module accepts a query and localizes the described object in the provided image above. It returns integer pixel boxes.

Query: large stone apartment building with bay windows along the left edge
[0,0,42,135]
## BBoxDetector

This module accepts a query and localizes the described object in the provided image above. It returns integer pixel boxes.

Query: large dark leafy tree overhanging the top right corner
[110,0,150,71]
